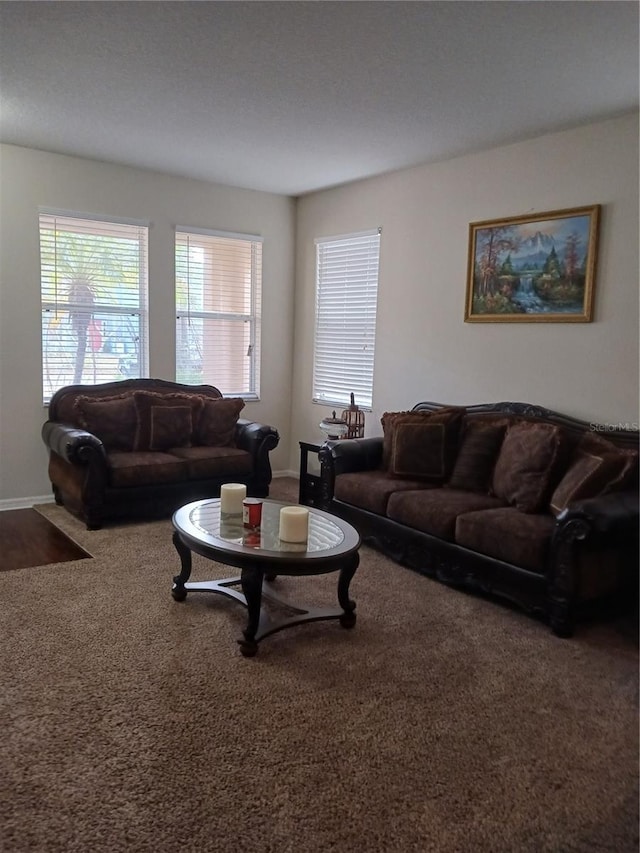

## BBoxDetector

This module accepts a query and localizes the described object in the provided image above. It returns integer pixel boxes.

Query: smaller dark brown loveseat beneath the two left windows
[42,379,279,529]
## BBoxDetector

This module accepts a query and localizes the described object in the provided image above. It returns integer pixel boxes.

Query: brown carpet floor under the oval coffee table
[0,479,638,853]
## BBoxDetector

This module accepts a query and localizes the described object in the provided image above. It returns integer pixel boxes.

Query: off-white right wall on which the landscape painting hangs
[291,114,639,467]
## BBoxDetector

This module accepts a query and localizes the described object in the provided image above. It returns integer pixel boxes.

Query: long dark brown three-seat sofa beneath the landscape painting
[320,402,638,636]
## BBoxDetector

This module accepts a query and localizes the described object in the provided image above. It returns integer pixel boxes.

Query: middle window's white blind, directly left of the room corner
[176,228,262,399]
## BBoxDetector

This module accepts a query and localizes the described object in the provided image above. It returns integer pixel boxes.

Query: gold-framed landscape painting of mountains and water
[464,204,600,323]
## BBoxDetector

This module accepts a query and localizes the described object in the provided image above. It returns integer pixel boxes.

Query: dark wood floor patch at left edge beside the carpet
[0,509,91,572]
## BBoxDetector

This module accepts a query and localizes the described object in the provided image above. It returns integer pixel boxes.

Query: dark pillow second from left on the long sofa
[447,421,507,494]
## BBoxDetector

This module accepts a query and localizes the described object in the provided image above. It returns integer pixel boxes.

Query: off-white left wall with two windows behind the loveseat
[0,145,295,508]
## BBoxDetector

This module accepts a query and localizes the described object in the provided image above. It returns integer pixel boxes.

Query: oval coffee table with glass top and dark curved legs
[171,498,360,657]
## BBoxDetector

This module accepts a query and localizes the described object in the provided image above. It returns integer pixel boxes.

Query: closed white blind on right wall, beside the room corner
[313,229,380,409]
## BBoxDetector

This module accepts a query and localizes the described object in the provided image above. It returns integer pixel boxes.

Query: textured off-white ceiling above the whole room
[0,0,639,196]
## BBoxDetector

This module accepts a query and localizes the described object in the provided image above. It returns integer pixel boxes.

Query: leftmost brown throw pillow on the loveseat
[73,393,137,451]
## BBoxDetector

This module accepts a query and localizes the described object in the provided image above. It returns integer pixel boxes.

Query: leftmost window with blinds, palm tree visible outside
[40,212,148,405]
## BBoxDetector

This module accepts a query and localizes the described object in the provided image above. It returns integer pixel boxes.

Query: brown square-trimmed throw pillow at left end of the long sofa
[380,406,465,483]
